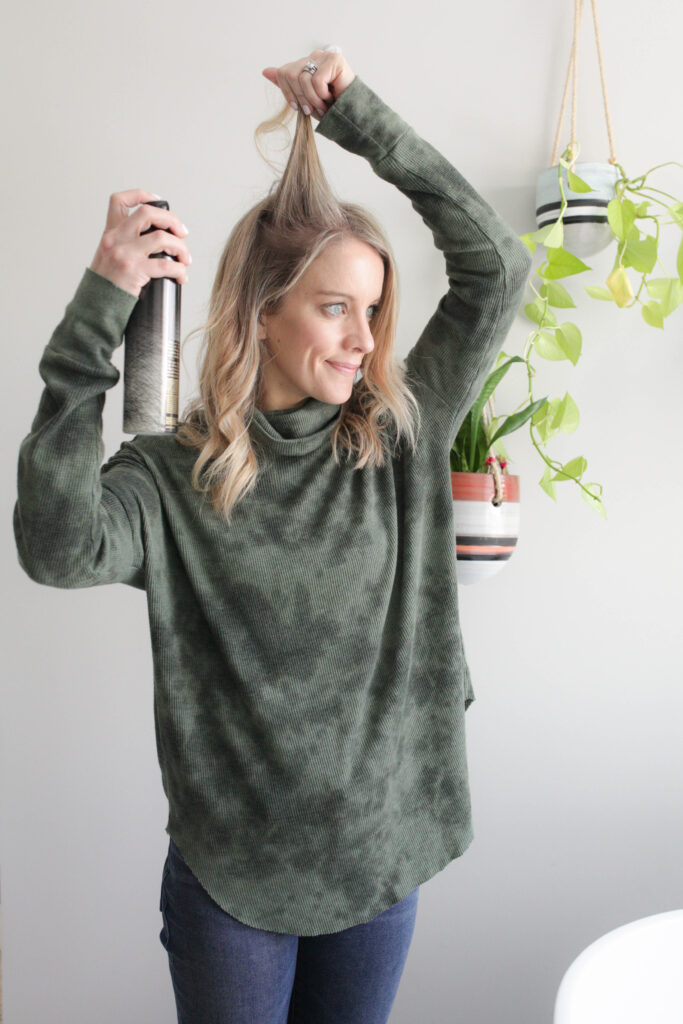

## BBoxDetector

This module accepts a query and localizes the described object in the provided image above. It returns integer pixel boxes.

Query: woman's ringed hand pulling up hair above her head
[261,50,355,121]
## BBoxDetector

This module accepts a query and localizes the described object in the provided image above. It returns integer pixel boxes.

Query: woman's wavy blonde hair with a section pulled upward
[176,93,420,522]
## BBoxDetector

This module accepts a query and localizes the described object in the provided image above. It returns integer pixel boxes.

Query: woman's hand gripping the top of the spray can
[90,188,191,297]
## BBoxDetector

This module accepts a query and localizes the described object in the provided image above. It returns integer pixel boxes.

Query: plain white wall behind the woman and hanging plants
[0,0,683,1024]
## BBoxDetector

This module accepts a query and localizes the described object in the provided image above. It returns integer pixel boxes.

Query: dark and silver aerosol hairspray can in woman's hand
[123,199,180,434]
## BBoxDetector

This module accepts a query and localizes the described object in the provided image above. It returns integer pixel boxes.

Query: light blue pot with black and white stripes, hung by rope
[536,164,620,257]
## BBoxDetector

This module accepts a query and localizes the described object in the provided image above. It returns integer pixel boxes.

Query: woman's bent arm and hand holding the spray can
[13,189,186,588]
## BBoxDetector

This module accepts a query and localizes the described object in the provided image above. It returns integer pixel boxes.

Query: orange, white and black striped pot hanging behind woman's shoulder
[451,472,519,584]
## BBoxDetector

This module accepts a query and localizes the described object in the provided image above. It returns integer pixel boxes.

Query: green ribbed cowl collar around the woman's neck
[250,397,342,455]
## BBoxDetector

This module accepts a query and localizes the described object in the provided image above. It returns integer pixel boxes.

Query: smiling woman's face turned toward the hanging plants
[258,237,384,412]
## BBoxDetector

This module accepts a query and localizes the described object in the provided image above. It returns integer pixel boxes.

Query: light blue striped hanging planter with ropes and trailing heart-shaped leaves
[520,0,683,517]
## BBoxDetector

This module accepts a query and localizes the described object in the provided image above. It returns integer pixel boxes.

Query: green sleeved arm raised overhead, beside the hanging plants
[315,75,531,442]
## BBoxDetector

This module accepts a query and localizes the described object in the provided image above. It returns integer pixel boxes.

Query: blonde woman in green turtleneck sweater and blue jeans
[14,50,530,1024]
